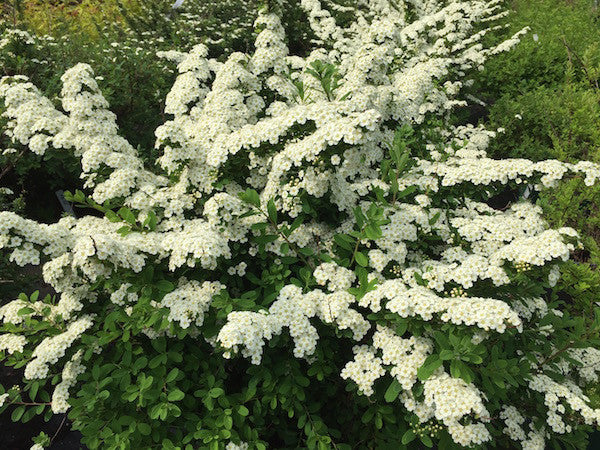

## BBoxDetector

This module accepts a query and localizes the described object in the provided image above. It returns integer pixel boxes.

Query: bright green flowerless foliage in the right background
[476,0,600,414]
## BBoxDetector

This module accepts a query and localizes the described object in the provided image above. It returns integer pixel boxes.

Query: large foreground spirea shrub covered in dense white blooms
[0,0,600,449]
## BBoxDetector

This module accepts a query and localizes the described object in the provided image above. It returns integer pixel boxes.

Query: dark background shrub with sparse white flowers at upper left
[0,0,308,225]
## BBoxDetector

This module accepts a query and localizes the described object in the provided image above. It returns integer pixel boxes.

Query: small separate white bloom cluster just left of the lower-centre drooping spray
[161,278,225,328]
